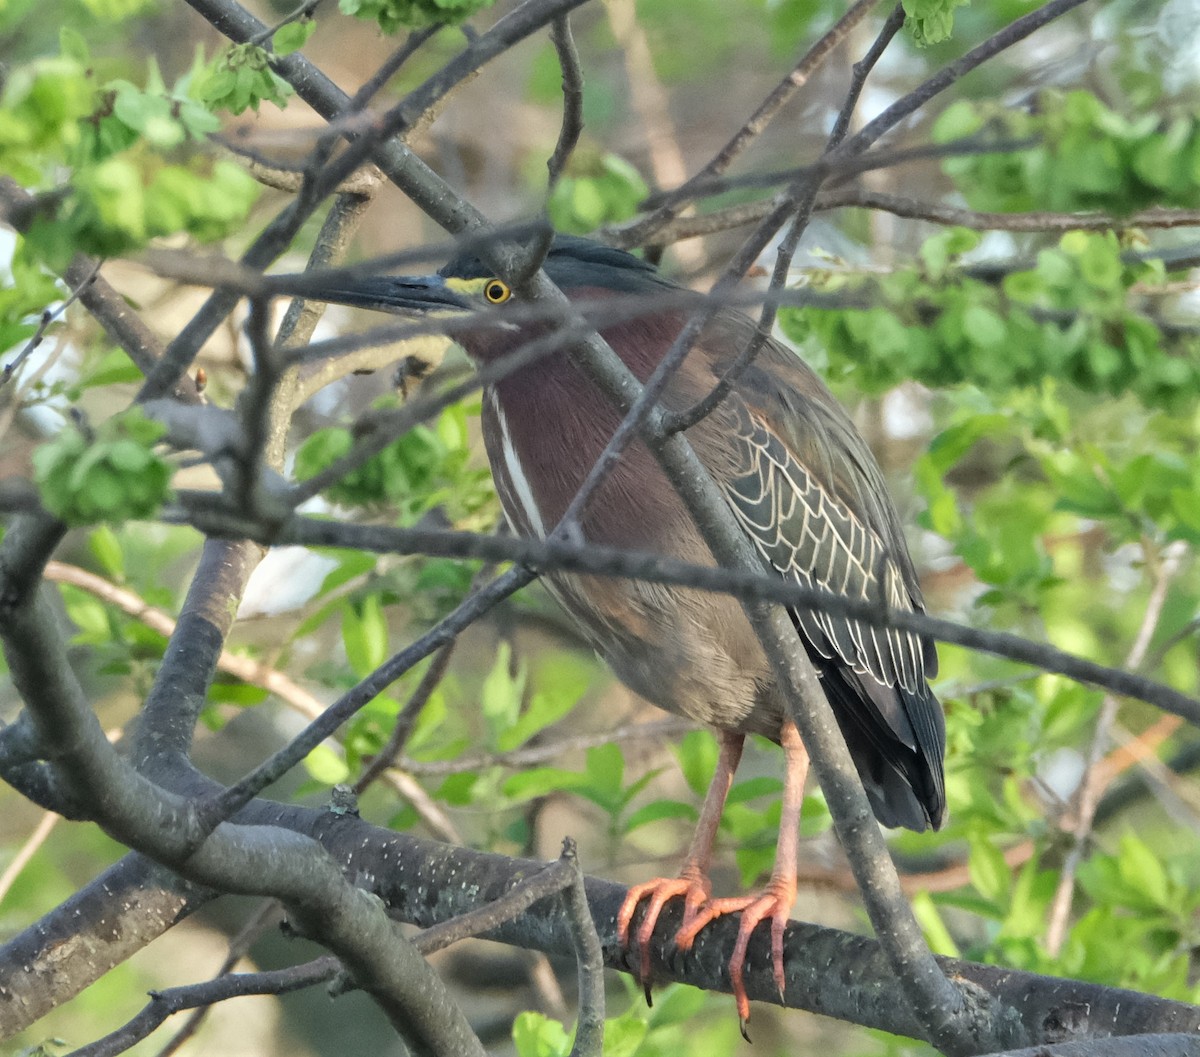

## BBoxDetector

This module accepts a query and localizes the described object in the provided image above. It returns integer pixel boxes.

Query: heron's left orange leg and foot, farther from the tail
[617,731,744,1002]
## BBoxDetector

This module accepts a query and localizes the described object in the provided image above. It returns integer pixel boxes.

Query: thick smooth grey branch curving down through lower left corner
[0,585,482,1057]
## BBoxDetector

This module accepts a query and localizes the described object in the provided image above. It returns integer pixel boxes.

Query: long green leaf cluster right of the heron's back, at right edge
[780,228,1200,409]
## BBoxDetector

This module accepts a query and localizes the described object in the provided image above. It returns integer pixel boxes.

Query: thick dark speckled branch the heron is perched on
[9,800,1200,1046]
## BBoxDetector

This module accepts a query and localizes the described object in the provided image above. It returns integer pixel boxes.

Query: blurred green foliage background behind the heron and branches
[0,0,1200,1057]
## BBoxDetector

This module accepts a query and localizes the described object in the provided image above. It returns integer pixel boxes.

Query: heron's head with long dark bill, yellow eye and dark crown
[296,235,676,360]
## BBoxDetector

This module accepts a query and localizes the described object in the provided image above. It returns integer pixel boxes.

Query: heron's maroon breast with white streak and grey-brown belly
[484,394,782,738]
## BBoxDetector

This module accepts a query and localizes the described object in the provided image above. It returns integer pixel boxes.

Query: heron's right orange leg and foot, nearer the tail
[676,721,809,1040]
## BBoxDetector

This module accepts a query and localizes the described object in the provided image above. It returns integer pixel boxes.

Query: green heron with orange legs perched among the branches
[302,236,946,1025]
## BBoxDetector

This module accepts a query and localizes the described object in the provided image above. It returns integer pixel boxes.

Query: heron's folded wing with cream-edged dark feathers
[697,316,946,829]
